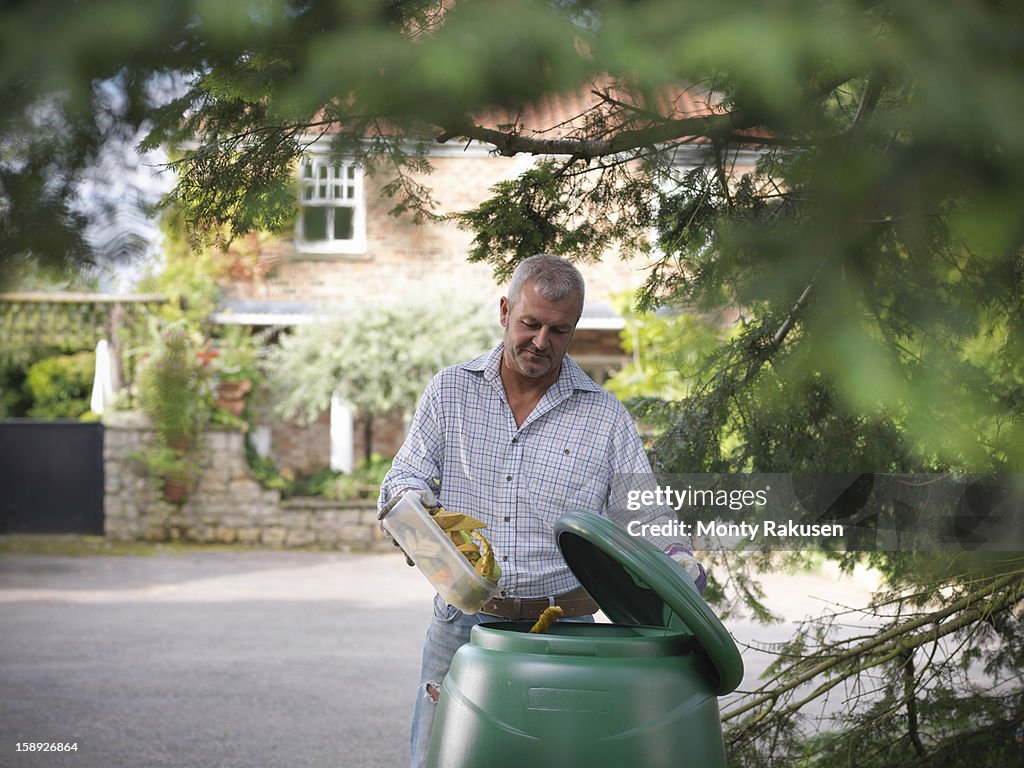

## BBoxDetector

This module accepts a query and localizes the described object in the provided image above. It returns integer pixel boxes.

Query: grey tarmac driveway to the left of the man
[0,551,432,768]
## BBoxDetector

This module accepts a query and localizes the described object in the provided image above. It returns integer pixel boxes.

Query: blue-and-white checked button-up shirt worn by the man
[380,344,692,598]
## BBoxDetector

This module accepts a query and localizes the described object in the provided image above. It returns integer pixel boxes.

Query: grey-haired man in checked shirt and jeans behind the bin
[380,254,706,768]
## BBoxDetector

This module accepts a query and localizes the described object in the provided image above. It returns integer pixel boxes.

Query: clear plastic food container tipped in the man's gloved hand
[382,492,501,613]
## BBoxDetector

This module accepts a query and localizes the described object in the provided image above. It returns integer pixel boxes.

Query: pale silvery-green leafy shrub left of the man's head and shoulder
[266,285,500,422]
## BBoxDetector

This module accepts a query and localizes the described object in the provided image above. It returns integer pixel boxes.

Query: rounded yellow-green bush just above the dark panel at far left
[25,352,95,419]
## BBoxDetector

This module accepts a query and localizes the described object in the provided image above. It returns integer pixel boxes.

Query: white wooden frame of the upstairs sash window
[295,152,367,255]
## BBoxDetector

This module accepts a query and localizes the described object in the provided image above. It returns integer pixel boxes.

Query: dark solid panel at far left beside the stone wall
[0,419,103,535]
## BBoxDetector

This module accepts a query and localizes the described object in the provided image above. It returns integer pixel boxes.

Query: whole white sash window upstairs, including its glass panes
[296,156,367,254]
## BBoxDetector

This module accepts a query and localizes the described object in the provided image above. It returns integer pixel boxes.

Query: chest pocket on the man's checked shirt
[523,442,610,522]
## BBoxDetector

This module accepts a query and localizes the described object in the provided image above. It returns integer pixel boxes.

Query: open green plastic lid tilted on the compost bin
[555,510,743,695]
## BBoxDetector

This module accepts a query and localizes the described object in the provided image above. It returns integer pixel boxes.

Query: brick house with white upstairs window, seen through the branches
[216,91,761,479]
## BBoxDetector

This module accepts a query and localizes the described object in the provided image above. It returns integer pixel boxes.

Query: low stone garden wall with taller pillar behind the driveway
[103,413,392,550]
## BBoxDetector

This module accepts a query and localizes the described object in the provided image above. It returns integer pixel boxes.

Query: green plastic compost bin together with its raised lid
[427,511,743,768]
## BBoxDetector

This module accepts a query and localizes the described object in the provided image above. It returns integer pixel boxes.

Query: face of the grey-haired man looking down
[501,283,580,379]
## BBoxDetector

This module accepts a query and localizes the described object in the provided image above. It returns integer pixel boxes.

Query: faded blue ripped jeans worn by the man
[410,595,594,768]
